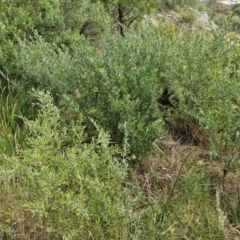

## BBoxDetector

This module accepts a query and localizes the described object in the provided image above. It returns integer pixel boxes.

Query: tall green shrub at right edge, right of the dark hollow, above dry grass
[156,26,239,163]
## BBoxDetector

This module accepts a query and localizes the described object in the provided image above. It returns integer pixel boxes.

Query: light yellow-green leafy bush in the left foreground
[0,92,133,239]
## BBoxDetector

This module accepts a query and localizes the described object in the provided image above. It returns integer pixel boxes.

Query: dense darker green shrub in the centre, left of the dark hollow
[76,34,166,157]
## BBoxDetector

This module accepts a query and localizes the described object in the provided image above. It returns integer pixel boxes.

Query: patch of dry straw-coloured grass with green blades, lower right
[137,134,240,240]
